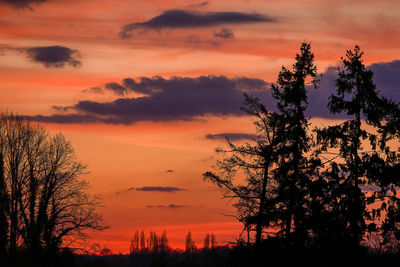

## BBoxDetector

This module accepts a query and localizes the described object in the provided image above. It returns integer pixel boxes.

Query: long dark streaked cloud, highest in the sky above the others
[119,9,276,38]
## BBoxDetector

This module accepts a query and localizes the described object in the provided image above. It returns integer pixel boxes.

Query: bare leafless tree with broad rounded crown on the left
[0,114,104,255]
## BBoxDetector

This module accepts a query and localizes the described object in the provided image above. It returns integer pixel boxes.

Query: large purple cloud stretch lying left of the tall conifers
[29,76,269,124]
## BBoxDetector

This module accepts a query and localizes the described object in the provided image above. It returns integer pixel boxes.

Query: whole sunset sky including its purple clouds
[0,0,400,253]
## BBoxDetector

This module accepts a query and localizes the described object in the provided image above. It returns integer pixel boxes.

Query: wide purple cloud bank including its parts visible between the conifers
[27,60,400,124]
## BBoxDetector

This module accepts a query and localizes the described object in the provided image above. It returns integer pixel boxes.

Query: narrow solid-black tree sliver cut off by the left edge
[0,151,9,256]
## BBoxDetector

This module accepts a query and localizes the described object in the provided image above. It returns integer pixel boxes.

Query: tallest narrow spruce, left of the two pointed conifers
[272,43,318,245]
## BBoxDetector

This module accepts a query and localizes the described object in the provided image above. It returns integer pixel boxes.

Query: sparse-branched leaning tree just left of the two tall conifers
[203,93,281,245]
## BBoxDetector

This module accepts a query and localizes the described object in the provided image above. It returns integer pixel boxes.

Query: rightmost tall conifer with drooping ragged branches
[317,46,400,249]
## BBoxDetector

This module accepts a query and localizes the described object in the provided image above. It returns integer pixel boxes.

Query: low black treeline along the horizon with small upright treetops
[74,231,400,267]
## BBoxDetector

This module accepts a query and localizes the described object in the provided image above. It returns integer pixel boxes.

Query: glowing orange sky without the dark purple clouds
[0,0,400,253]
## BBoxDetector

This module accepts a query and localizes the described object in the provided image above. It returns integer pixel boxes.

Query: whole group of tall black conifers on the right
[203,43,400,253]
